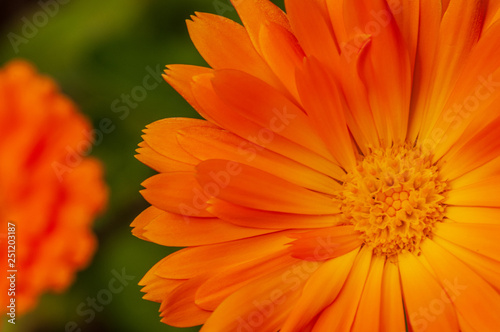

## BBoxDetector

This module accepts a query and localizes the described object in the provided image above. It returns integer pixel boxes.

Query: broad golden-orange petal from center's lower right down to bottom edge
[398,252,458,332]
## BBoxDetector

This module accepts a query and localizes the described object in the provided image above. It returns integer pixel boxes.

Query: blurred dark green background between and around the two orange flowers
[0,0,283,332]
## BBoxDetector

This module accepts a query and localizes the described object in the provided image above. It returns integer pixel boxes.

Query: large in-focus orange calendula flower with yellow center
[133,0,500,332]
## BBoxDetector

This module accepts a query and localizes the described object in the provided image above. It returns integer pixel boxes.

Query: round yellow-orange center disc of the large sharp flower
[340,144,446,256]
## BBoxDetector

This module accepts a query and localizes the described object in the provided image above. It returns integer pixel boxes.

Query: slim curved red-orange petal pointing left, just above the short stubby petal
[207,199,342,229]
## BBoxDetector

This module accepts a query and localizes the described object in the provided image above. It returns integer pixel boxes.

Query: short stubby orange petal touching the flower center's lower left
[290,226,363,261]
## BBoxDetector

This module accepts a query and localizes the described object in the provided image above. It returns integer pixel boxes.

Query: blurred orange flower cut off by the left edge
[0,60,107,316]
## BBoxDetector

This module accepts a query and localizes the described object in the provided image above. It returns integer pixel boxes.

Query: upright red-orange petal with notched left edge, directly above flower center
[345,0,411,146]
